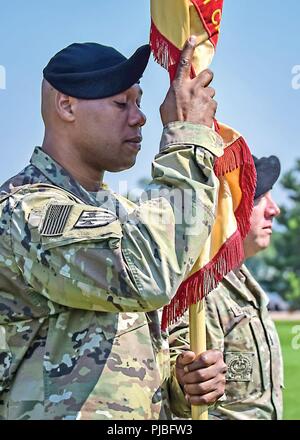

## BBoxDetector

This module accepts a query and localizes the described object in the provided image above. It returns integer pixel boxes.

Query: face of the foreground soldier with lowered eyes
[74,84,146,172]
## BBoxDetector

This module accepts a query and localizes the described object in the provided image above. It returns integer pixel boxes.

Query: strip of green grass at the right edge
[275,321,300,420]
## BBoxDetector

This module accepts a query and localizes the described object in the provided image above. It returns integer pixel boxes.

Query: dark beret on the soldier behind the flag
[253,156,281,200]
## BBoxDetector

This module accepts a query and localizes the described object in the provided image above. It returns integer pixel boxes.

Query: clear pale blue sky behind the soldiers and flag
[0,0,300,202]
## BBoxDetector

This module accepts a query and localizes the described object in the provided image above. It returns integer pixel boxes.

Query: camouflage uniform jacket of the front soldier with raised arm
[0,122,223,419]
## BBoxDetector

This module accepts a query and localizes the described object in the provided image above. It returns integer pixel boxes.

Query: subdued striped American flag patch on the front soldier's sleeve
[41,204,72,236]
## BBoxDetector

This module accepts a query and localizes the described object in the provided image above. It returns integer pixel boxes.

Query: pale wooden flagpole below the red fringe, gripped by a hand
[189,299,208,420]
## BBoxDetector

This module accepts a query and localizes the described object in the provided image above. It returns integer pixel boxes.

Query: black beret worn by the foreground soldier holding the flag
[43,43,150,99]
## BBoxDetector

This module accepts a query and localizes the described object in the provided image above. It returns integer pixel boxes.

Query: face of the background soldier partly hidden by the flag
[244,191,280,258]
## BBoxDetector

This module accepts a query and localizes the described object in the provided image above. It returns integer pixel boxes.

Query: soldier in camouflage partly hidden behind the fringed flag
[171,156,283,420]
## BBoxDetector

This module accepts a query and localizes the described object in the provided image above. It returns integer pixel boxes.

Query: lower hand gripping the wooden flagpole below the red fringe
[176,350,227,405]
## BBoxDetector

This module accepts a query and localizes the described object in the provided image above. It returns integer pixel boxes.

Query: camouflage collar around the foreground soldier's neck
[30,147,106,206]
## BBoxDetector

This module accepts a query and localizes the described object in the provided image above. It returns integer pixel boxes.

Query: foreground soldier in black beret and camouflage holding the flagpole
[0,40,226,420]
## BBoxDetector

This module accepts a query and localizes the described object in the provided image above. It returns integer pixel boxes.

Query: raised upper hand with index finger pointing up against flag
[160,36,217,128]
